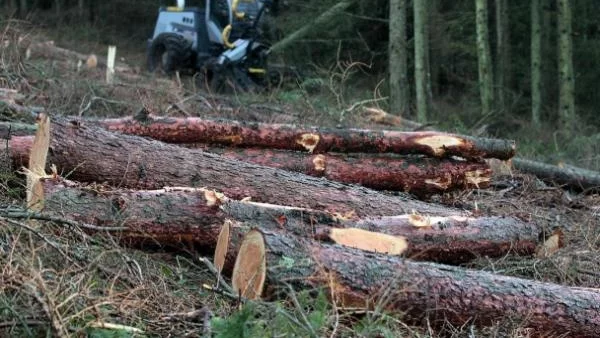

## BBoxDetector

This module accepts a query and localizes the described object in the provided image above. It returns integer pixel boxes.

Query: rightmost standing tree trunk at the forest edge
[557,0,575,125]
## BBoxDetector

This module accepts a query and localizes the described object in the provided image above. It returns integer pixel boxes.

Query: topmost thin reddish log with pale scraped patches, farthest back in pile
[98,114,515,159]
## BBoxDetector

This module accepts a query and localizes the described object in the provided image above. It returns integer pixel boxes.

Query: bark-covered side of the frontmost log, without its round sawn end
[263,232,600,337]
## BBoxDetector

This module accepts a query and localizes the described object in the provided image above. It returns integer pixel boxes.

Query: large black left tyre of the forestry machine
[148,33,192,74]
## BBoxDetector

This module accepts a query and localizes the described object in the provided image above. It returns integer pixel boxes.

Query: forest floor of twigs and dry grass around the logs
[0,21,600,337]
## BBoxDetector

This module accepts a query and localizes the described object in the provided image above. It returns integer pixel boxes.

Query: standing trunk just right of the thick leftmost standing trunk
[413,1,430,123]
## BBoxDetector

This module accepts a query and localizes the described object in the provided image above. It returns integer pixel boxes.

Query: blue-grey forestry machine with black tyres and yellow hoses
[147,0,277,91]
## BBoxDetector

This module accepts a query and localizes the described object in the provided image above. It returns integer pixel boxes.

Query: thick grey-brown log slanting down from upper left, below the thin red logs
[42,118,459,216]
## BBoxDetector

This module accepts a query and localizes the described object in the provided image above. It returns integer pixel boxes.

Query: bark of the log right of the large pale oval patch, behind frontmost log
[346,215,542,264]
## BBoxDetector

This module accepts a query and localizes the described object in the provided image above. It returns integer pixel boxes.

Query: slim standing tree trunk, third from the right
[495,0,511,110]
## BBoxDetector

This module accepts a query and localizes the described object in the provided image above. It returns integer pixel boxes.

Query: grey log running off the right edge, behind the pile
[512,158,600,192]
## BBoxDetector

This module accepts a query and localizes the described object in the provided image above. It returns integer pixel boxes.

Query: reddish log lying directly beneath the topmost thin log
[197,147,491,196]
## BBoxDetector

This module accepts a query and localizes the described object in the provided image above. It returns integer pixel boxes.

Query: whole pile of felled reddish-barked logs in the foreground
[3,114,600,337]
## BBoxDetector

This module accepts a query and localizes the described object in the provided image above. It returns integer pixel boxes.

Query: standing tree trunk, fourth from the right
[475,0,494,116]
